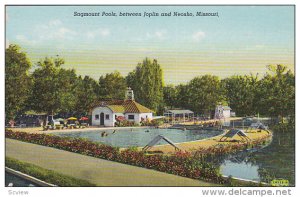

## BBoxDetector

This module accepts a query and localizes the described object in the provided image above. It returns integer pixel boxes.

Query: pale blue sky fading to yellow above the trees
[6,6,294,84]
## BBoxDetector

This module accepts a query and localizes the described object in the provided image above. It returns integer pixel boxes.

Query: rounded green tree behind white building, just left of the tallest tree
[98,71,127,99]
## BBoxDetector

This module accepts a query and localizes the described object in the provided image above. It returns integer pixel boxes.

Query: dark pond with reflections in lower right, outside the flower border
[219,119,295,186]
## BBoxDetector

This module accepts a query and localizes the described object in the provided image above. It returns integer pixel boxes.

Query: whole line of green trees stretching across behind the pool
[5,45,295,124]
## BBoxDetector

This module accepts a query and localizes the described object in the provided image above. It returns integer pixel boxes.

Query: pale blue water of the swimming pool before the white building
[55,128,222,148]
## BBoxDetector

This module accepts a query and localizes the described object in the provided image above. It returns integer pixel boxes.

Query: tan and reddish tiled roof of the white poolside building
[93,100,153,113]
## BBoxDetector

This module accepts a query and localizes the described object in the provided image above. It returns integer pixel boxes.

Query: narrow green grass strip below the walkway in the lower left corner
[5,157,96,187]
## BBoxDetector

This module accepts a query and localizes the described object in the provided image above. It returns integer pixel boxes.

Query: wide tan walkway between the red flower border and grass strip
[6,138,216,186]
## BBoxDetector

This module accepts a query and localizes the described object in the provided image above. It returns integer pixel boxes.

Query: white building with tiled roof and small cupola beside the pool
[92,88,153,127]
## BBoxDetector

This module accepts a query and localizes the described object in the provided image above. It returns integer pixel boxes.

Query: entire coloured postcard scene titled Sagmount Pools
[3,5,296,192]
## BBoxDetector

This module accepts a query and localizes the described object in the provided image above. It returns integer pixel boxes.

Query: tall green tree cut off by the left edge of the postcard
[5,44,31,121]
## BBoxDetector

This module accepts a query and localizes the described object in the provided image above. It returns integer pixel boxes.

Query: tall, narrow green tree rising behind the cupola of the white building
[126,58,164,114]
